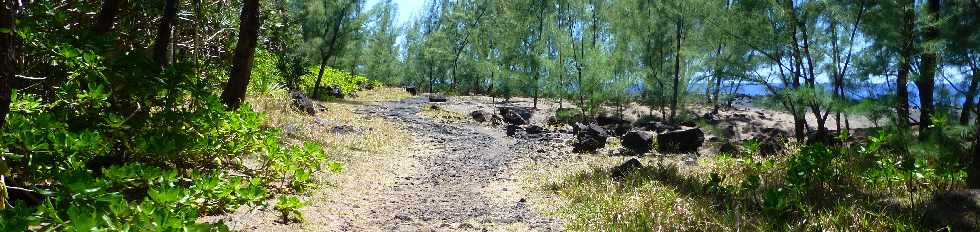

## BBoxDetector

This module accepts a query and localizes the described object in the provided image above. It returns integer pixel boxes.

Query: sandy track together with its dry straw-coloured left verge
[210,92,562,231]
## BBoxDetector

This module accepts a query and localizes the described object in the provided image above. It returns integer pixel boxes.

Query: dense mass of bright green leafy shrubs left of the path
[0,2,341,231]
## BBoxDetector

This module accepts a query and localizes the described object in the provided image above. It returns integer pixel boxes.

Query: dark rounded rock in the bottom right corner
[923,189,980,231]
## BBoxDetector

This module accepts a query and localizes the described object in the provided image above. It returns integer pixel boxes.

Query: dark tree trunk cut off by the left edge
[0,1,16,129]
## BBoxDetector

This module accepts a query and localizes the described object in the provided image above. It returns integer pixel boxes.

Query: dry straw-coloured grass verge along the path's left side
[216,88,424,231]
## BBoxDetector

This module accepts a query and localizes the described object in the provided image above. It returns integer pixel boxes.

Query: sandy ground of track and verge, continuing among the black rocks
[208,89,873,231]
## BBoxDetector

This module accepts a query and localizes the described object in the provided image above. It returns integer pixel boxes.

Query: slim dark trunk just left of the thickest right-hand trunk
[895,0,915,128]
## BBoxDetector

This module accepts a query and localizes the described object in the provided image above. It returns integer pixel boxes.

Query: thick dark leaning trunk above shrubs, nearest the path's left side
[221,0,259,109]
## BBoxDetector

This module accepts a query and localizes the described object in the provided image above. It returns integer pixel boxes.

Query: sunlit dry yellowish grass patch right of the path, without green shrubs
[547,148,929,231]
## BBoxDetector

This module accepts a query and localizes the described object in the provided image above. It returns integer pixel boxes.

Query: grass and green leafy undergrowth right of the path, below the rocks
[548,125,965,231]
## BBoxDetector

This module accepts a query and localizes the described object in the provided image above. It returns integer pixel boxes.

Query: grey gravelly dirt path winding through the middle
[318,97,560,231]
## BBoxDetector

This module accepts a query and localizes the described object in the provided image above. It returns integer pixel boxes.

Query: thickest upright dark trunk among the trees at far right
[916,0,941,138]
